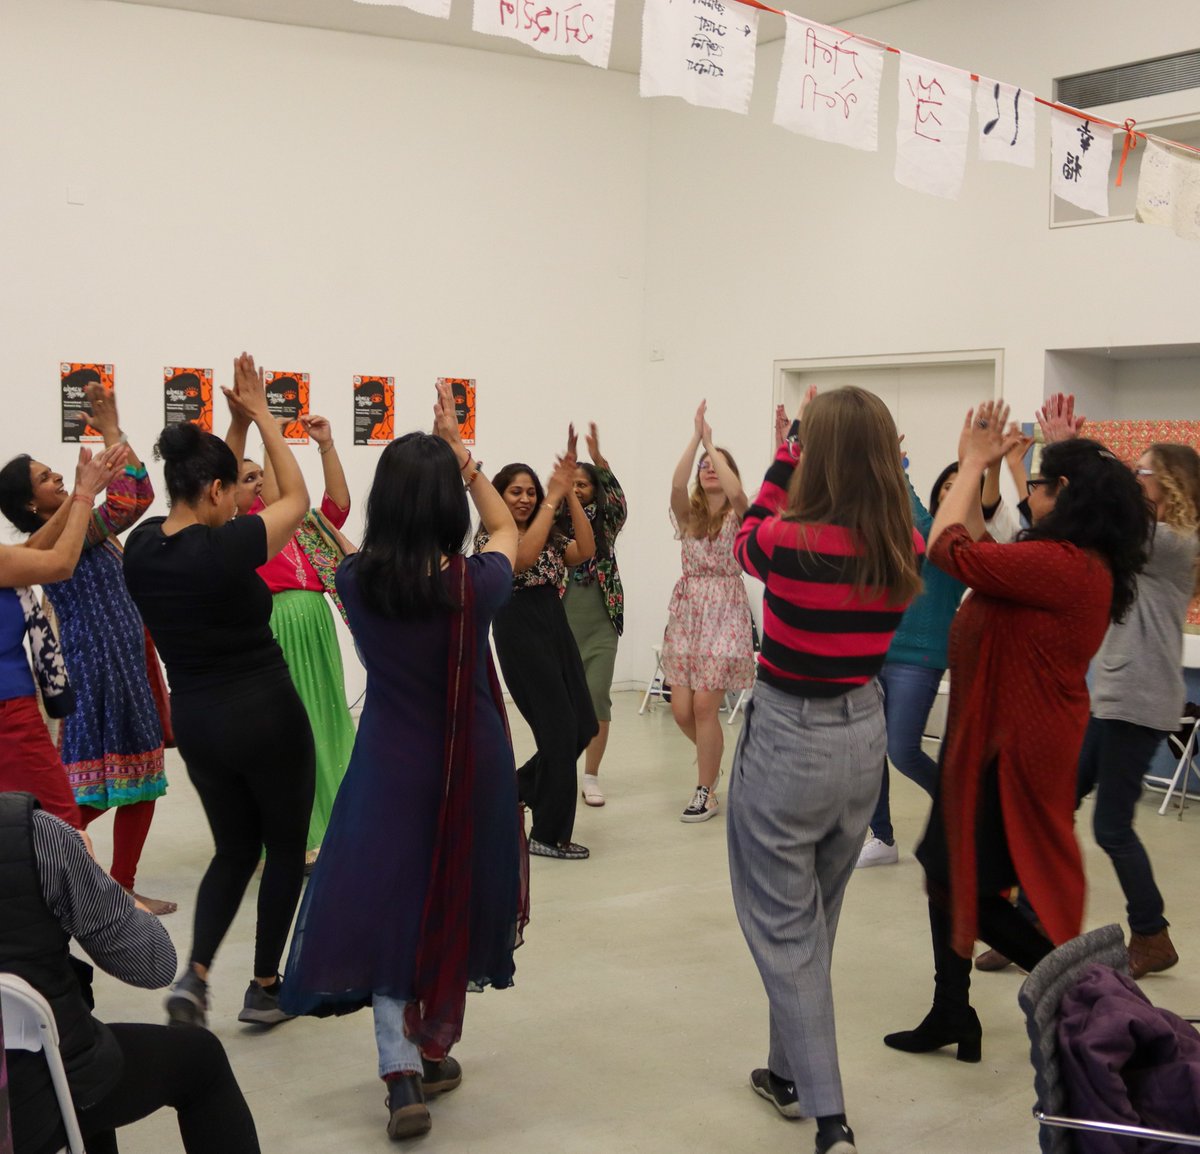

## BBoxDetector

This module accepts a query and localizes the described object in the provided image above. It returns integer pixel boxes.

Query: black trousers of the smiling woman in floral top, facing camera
[492,585,599,846]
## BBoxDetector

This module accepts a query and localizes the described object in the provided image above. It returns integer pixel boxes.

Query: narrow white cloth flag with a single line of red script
[895,52,971,200]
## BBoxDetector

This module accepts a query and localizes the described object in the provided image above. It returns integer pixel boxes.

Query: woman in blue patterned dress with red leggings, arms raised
[0,383,175,915]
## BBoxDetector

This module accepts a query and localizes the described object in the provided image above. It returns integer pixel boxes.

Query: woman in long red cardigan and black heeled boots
[883,402,1150,1062]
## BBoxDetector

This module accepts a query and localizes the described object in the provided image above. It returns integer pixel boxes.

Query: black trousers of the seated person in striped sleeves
[38,1022,259,1154]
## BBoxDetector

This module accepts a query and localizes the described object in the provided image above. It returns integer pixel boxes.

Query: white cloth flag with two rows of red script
[775,12,886,152]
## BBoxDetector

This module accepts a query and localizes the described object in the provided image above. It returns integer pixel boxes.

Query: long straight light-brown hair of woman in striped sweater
[782,385,920,606]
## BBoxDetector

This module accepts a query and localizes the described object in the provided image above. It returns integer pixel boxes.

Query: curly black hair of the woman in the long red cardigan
[1020,437,1153,621]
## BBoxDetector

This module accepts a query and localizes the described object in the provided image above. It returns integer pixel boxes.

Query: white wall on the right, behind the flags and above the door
[643,0,1200,662]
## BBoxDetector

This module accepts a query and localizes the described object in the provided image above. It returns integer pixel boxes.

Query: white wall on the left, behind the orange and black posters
[0,0,648,698]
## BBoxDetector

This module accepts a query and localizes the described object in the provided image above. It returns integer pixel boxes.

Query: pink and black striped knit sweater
[734,444,924,697]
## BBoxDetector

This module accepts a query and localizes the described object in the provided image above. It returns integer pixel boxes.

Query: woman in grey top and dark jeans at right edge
[1079,444,1200,978]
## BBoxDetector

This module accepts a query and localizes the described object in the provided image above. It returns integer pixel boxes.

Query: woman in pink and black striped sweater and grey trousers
[727,387,924,1154]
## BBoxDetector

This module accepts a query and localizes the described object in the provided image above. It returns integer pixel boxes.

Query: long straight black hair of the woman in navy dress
[355,433,470,618]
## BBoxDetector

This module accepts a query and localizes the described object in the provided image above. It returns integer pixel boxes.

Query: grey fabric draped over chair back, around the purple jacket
[1016,925,1129,1154]
